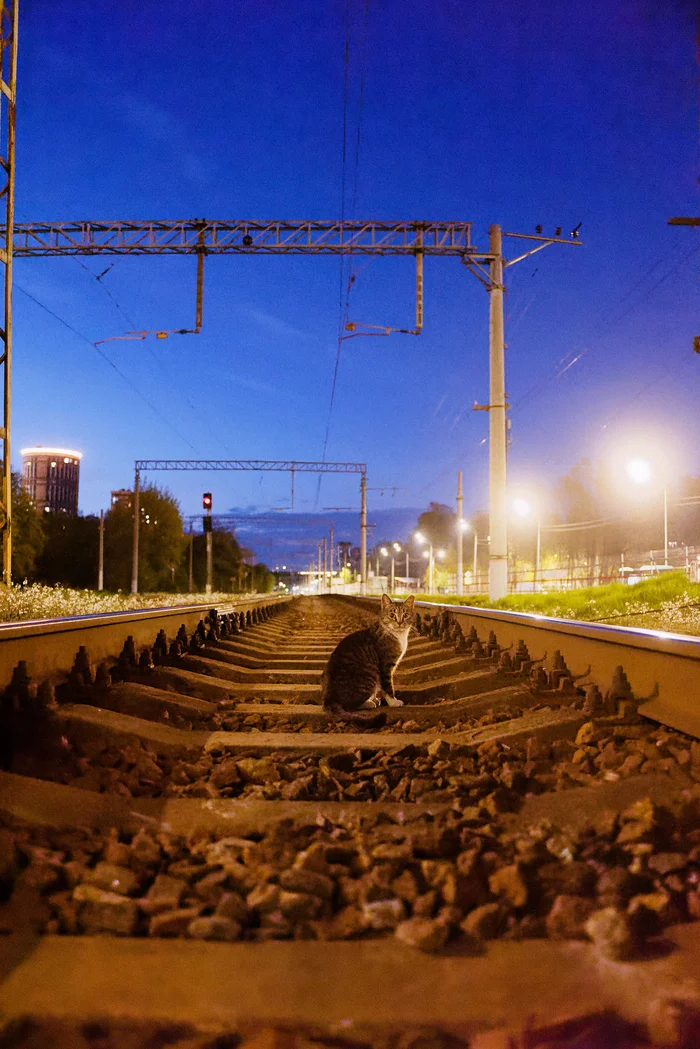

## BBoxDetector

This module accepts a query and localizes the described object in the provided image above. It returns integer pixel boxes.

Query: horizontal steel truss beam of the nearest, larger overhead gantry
[5,219,472,256]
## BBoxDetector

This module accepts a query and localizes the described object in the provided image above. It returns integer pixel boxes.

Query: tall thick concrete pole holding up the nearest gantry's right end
[488,226,508,601]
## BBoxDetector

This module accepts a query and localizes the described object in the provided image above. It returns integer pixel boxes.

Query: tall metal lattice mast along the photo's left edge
[0,0,18,585]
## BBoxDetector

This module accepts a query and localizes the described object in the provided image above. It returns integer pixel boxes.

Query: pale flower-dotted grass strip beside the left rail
[0,583,257,623]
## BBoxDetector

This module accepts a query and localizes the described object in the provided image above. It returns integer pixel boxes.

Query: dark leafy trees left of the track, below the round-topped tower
[13,474,275,593]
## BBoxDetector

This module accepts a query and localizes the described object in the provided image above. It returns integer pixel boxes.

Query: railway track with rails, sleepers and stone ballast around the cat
[0,598,700,1049]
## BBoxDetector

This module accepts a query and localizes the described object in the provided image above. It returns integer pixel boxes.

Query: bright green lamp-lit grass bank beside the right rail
[417,572,700,635]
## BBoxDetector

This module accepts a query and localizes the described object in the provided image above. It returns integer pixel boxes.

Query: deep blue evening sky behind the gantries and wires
[13,0,700,556]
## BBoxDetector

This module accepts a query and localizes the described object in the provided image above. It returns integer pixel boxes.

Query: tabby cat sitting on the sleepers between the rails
[321,594,413,722]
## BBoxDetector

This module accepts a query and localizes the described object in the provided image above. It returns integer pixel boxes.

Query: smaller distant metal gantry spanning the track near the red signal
[131,459,367,594]
